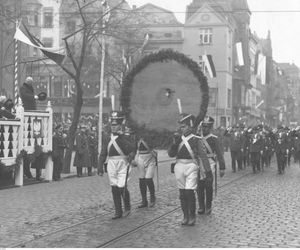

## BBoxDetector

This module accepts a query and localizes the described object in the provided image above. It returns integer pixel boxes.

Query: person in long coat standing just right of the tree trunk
[74,125,92,177]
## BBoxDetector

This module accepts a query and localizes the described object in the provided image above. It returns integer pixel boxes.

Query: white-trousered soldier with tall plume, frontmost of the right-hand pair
[168,114,212,226]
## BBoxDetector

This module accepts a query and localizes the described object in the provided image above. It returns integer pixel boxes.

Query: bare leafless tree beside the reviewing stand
[55,0,148,172]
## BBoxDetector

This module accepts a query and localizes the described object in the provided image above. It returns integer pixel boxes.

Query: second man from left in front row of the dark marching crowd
[250,127,263,173]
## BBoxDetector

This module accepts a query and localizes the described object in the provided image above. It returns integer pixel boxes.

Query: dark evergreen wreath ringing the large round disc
[120,49,209,148]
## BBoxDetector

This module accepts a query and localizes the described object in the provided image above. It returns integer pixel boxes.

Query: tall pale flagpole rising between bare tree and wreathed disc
[98,5,105,156]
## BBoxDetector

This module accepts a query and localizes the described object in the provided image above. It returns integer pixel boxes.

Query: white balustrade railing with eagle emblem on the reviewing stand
[0,101,53,186]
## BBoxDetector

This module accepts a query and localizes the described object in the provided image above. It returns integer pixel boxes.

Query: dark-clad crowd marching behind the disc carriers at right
[224,124,300,174]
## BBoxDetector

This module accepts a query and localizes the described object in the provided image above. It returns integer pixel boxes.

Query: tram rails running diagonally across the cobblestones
[11,166,251,248]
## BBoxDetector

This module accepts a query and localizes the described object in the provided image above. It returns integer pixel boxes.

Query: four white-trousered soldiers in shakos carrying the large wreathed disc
[98,111,225,226]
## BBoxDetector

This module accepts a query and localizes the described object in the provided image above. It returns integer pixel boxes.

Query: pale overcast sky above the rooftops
[127,0,300,67]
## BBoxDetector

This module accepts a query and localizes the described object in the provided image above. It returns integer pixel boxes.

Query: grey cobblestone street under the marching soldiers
[0,152,300,248]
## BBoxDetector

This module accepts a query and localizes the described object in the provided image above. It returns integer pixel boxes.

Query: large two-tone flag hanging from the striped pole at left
[14,24,65,64]
